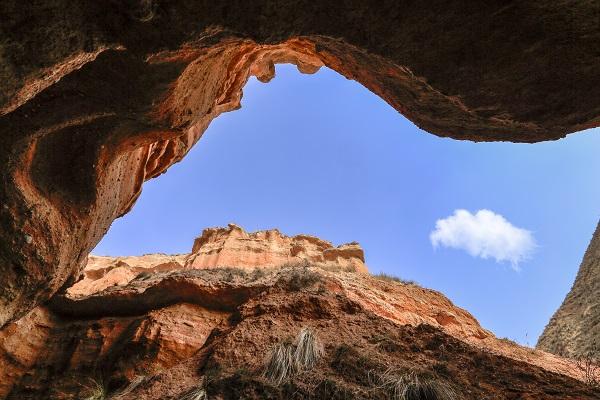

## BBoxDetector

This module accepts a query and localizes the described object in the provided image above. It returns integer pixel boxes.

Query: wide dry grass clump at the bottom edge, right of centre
[374,369,458,400]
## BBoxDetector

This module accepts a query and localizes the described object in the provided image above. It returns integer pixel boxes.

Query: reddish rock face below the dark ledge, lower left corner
[0,303,229,399]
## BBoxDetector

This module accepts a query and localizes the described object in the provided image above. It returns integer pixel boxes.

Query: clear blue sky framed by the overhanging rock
[94,65,600,345]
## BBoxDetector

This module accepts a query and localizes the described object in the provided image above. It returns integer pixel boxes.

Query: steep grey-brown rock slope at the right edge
[537,223,600,360]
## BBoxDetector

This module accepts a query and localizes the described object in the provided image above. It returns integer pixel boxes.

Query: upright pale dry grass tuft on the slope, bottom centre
[263,328,325,386]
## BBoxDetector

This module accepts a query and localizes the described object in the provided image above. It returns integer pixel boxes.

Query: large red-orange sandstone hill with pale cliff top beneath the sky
[0,225,597,400]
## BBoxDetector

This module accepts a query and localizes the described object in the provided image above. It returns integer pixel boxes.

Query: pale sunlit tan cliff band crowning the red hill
[67,224,367,295]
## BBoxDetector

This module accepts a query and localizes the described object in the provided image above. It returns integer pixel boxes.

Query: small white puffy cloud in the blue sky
[429,210,536,270]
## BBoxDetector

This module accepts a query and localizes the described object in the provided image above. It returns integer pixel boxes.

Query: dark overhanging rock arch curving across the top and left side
[0,0,600,326]
